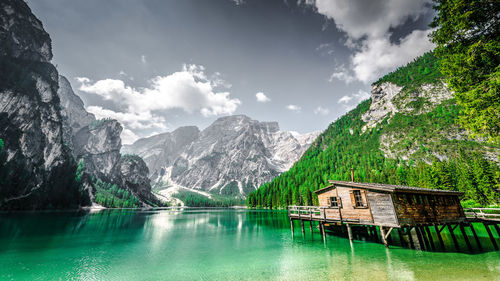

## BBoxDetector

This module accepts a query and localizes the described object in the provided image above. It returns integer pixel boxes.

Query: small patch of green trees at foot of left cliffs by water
[93,179,140,208]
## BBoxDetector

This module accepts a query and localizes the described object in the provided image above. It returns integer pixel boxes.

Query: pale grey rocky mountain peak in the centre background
[122,115,318,196]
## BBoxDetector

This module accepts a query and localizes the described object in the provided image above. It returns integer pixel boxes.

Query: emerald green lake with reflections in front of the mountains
[0,209,500,280]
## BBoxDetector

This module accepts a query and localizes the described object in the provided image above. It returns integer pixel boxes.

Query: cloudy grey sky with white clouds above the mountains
[27,0,433,143]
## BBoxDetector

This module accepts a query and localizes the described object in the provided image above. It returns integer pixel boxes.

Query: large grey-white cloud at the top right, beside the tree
[309,0,434,83]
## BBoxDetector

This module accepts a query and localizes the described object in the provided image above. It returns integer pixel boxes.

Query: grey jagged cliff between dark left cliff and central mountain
[58,76,158,206]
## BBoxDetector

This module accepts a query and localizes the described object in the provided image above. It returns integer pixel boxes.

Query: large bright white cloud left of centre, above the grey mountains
[76,65,241,140]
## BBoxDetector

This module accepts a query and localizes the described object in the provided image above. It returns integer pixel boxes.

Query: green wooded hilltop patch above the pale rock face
[374,52,443,88]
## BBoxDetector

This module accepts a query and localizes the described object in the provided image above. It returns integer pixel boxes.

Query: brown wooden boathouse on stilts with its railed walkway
[288,181,500,250]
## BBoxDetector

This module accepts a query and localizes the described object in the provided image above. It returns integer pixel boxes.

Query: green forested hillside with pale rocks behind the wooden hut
[247,53,500,208]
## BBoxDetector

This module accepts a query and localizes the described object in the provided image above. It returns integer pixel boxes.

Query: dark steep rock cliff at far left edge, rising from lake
[0,0,88,209]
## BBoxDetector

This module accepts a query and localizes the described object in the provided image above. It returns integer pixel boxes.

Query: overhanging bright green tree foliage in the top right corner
[431,0,500,143]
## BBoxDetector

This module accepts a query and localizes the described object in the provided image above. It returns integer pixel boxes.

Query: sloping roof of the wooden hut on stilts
[315,180,464,195]
